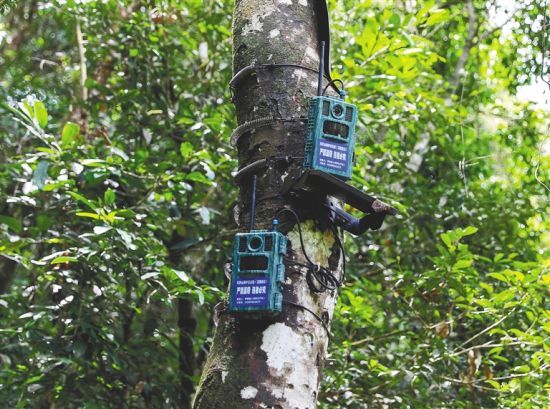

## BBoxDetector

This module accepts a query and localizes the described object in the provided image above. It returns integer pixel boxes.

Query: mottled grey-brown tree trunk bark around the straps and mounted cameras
[194,0,342,409]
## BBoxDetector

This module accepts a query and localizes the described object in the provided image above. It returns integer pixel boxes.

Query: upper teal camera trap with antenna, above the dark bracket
[303,42,357,180]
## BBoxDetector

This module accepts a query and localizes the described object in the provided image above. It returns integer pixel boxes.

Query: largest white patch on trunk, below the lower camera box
[261,322,318,409]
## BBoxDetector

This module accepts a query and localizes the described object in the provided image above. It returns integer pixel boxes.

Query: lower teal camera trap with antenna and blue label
[229,175,287,315]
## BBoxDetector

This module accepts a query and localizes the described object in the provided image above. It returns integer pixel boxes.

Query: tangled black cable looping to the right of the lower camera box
[275,207,346,293]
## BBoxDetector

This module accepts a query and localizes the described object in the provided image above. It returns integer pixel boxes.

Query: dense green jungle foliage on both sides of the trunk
[0,0,550,409]
